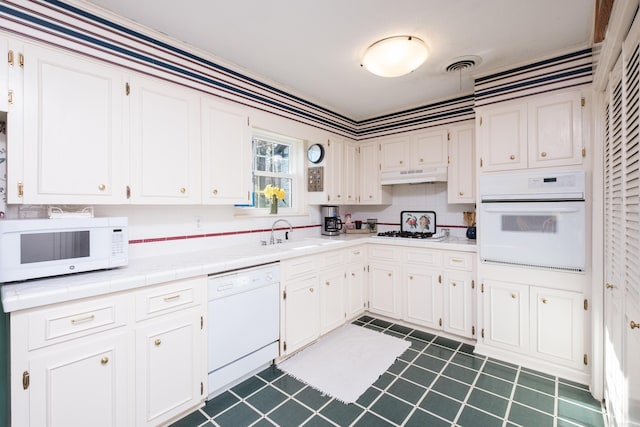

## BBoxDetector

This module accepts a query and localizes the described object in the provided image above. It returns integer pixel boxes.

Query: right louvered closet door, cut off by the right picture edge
[622,18,640,425]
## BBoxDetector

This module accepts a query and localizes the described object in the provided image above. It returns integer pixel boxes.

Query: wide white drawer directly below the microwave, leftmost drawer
[28,295,127,350]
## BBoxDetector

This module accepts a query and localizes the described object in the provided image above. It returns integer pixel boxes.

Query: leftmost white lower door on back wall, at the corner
[369,263,400,319]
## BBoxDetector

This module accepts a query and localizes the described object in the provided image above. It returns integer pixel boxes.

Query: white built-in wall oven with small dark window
[478,171,586,272]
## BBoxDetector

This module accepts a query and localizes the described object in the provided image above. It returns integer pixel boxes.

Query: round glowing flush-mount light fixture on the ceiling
[361,36,427,77]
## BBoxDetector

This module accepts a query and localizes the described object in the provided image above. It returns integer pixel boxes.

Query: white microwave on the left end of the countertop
[0,217,129,283]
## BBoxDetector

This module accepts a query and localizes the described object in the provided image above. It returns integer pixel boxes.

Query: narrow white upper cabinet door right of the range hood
[447,125,476,203]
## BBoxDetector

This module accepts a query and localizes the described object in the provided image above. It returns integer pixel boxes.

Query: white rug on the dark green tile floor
[278,324,411,403]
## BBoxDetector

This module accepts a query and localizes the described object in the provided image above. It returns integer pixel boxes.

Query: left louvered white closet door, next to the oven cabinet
[604,57,625,426]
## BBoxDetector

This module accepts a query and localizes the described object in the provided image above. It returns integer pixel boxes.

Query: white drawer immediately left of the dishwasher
[136,277,207,320]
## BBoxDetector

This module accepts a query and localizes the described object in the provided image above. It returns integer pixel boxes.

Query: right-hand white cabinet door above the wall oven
[528,91,582,168]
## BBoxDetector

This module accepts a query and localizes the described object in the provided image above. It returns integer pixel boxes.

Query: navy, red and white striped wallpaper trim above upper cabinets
[0,0,593,141]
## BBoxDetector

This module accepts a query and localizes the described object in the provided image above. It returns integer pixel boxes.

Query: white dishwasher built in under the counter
[207,263,280,398]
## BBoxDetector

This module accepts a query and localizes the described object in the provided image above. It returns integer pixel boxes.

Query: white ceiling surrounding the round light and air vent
[87,0,595,120]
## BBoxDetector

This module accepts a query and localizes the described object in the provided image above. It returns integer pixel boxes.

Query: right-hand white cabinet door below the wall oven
[530,287,585,369]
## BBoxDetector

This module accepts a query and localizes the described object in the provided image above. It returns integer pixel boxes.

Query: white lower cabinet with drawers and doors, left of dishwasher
[10,276,207,427]
